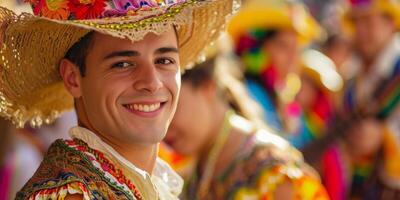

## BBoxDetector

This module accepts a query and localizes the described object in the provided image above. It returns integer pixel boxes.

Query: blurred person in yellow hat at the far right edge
[322,0,400,199]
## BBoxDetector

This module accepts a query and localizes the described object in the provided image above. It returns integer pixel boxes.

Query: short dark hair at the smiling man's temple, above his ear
[64,31,94,77]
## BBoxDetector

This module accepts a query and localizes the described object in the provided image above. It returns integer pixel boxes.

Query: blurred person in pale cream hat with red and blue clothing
[288,50,343,150]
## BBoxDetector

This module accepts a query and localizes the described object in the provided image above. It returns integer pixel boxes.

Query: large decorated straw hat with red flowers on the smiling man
[0,0,238,127]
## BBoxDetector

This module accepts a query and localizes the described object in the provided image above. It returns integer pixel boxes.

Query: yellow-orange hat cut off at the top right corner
[343,0,400,33]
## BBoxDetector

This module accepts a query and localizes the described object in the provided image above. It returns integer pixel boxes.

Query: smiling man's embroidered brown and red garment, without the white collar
[16,140,142,200]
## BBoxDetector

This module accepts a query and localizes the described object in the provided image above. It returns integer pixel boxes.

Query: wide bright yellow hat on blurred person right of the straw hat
[228,0,323,44]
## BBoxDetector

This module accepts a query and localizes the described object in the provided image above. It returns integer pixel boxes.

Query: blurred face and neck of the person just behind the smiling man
[165,82,223,156]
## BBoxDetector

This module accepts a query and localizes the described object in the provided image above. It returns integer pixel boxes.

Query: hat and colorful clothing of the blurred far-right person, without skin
[322,0,400,200]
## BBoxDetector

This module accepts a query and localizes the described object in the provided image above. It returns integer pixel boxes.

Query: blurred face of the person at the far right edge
[351,9,396,65]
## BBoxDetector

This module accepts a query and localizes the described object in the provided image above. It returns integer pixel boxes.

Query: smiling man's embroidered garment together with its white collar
[17,127,183,199]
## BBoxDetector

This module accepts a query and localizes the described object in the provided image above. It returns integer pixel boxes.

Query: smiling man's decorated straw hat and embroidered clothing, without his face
[0,0,239,200]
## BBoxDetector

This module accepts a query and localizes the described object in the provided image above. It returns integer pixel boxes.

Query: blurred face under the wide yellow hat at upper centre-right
[263,30,300,78]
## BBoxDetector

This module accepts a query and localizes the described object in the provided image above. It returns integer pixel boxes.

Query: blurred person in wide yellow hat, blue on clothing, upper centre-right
[228,0,322,132]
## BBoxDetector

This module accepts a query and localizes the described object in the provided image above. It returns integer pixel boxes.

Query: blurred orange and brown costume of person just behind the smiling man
[182,112,328,200]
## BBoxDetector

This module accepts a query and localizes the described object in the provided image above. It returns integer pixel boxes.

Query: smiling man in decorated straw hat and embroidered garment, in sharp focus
[0,0,238,200]
